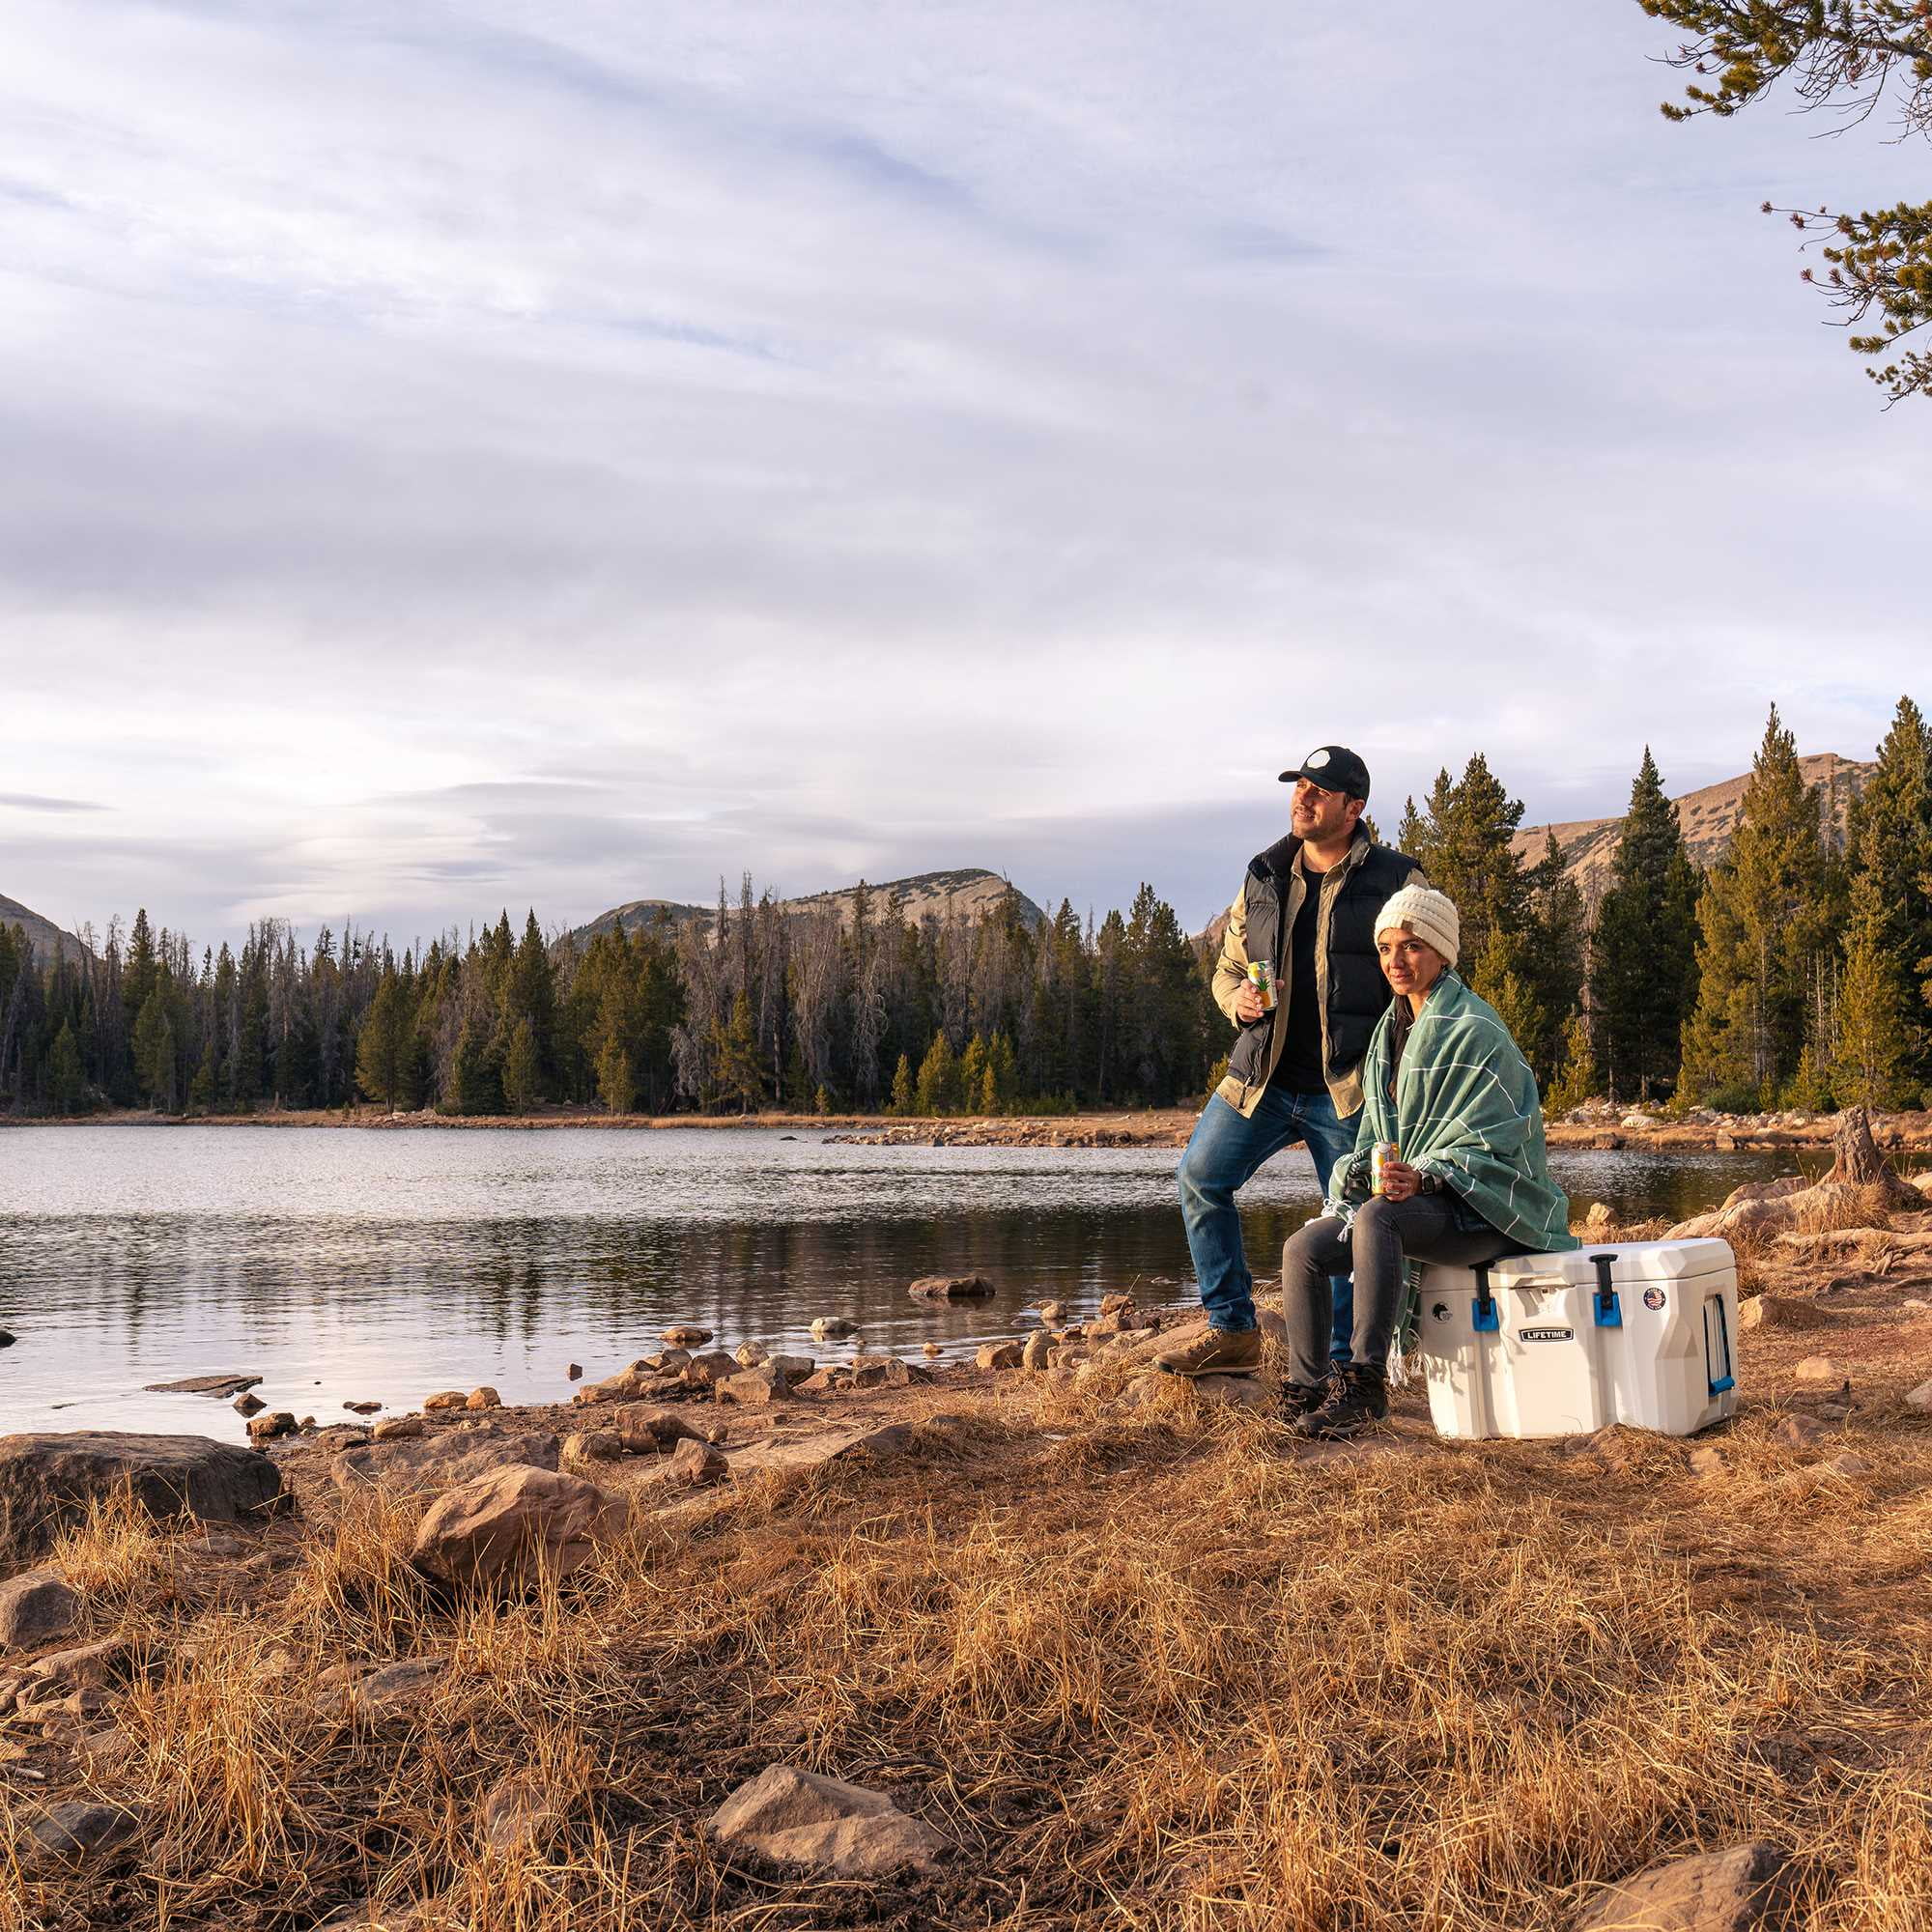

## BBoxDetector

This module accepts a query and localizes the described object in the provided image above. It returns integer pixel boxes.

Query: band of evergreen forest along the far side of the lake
[0,697,1932,1115]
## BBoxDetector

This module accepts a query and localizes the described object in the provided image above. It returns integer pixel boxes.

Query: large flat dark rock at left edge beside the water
[0,1430,282,1567]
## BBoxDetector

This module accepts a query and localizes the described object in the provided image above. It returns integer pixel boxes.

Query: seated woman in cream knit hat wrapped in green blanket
[1281,885,1577,1435]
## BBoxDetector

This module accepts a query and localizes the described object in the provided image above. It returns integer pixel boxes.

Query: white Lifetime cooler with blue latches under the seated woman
[1416,1240,1737,1439]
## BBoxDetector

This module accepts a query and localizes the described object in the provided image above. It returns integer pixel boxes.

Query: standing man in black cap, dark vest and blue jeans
[1153,744,1422,1376]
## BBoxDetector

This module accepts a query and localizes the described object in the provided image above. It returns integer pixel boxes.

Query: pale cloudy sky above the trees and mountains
[0,0,1932,939]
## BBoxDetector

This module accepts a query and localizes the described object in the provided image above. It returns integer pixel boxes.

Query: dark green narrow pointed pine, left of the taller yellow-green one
[1590,746,1698,1101]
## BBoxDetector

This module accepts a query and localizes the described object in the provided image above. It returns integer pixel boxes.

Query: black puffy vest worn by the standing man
[1227,835,1422,1088]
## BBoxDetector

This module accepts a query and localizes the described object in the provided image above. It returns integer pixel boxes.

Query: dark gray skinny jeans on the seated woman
[1281,1194,1528,1389]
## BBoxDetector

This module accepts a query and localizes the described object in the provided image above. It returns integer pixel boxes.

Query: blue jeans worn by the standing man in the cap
[1177,1088,1360,1362]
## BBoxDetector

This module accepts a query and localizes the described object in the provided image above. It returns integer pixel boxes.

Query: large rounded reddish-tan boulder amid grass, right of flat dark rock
[410,1464,626,1590]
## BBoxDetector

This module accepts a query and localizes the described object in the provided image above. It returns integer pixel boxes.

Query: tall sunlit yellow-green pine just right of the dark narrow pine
[1681,705,1833,1107]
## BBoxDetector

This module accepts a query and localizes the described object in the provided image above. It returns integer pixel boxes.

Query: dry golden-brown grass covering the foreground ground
[11,1378,1932,1932]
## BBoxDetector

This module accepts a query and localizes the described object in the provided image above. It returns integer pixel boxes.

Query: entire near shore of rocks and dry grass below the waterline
[11,1182,1932,1932]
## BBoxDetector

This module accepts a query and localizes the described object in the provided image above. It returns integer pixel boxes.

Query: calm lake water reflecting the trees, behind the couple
[0,1126,1791,1439]
